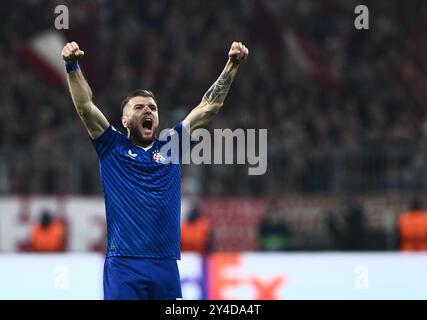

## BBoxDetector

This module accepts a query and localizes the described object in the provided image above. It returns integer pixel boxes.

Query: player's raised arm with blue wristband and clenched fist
[62,42,110,139]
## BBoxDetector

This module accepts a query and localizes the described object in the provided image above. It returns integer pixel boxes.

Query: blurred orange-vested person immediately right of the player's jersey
[181,206,213,253]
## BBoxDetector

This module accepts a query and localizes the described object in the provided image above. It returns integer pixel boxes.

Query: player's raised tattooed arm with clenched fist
[183,42,249,132]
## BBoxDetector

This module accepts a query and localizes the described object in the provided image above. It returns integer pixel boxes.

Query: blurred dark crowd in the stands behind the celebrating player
[0,0,427,196]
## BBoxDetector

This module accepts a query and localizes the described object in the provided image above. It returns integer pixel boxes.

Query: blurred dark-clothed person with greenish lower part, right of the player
[258,202,290,251]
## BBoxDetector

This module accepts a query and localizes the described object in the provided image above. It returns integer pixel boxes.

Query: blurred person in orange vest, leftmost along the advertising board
[30,210,66,252]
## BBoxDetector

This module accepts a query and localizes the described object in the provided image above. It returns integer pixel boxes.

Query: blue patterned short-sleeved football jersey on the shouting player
[92,122,186,259]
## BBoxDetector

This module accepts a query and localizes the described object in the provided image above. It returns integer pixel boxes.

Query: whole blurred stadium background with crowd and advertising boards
[0,0,427,299]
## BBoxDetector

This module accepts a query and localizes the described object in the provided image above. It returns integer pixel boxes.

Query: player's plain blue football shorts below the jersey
[104,257,182,300]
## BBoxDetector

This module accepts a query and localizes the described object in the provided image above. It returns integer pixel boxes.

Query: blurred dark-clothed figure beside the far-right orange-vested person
[327,200,370,251]
